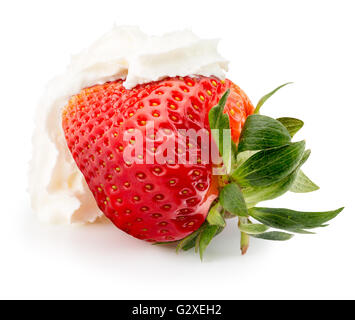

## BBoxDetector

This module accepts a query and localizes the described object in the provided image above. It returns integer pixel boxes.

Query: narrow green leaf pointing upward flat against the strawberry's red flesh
[208,90,236,173]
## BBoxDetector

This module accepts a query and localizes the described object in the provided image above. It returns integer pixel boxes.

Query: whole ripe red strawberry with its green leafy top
[62,76,343,259]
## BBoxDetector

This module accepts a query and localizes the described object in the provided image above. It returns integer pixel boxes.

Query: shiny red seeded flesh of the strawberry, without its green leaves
[63,77,254,242]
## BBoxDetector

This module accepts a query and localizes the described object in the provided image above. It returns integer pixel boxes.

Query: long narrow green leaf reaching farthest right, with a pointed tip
[249,207,344,233]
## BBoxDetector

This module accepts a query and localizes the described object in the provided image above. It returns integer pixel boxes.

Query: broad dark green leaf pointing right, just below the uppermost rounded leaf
[232,141,305,187]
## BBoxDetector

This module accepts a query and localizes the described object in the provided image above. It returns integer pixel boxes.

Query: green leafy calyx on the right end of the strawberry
[172,83,343,260]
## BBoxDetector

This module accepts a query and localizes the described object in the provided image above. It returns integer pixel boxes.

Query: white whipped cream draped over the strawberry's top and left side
[29,27,228,223]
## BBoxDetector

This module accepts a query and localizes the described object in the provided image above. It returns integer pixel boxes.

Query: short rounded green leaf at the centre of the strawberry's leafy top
[219,183,248,217]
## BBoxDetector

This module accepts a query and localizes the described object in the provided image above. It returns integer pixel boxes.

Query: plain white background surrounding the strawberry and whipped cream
[0,0,355,299]
